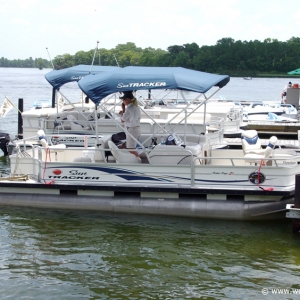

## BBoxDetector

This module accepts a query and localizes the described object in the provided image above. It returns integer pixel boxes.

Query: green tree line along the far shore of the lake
[0,37,300,76]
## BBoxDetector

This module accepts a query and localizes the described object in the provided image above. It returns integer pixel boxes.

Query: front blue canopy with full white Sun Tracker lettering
[78,67,230,106]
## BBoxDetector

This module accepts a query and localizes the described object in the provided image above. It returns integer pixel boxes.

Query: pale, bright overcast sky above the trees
[0,0,300,60]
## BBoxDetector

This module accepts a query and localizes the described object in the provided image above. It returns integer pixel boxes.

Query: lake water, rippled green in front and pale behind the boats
[0,69,300,299]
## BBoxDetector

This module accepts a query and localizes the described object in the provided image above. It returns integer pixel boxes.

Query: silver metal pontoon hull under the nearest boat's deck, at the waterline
[0,182,294,221]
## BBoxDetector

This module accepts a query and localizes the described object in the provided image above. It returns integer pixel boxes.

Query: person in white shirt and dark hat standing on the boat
[119,91,141,157]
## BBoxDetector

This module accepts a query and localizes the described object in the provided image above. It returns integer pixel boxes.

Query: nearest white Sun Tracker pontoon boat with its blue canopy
[0,67,300,220]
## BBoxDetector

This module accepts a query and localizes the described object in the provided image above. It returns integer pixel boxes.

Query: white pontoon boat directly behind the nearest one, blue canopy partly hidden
[15,65,230,148]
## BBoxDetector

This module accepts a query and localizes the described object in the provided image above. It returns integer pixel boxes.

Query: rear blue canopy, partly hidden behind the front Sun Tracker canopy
[45,65,119,89]
